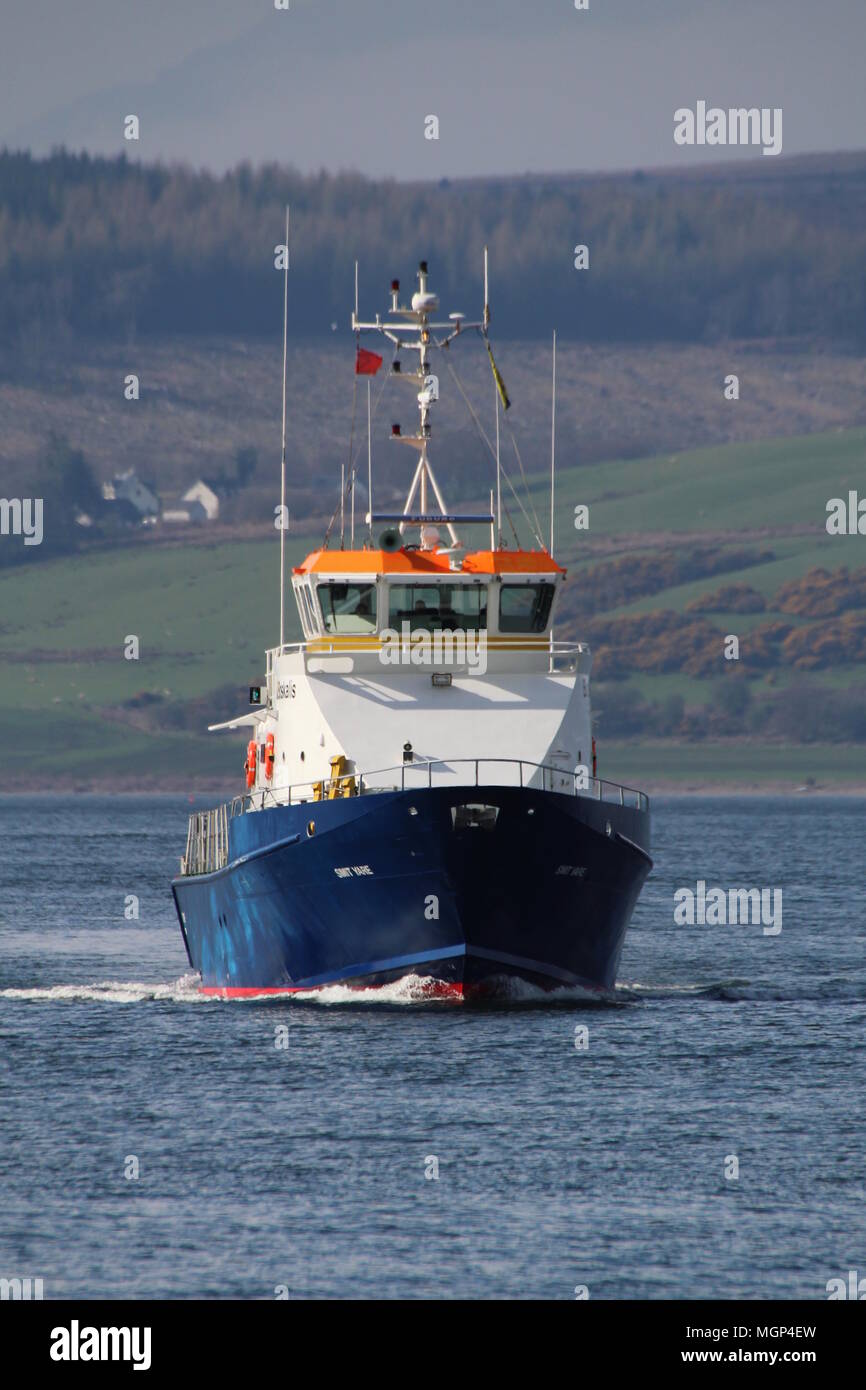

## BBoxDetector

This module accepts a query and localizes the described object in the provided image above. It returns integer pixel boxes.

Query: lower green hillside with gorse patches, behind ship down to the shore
[0,430,866,791]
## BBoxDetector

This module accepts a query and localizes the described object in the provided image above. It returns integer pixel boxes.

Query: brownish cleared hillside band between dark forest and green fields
[0,333,866,528]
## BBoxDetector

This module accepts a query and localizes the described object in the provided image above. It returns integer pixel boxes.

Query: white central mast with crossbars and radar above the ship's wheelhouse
[352,256,491,546]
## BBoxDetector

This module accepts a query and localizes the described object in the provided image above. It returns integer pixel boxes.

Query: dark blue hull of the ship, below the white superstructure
[172,787,652,997]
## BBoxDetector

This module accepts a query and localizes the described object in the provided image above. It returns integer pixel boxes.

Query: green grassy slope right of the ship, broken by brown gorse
[532,430,866,722]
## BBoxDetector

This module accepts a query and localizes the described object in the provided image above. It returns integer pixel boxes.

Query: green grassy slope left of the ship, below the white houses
[0,537,311,784]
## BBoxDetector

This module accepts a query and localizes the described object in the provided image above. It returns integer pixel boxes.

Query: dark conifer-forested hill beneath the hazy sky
[0,152,866,353]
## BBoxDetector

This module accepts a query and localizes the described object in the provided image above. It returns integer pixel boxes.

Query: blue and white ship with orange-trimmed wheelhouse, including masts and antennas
[172,247,652,1001]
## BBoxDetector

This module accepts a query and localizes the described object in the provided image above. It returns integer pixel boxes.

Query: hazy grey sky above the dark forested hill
[0,0,866,178]
